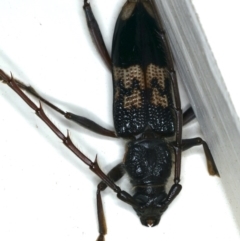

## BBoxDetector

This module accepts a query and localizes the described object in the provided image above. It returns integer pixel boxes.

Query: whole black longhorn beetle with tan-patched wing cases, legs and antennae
[0,0,219,241]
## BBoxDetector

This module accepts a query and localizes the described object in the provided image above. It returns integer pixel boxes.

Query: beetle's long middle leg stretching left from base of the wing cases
[0,69,116,137]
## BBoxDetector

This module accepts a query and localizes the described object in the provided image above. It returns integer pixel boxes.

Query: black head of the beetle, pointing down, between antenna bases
[134,192,168,227]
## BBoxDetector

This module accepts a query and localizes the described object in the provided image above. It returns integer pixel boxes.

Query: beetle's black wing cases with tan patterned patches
[112,1,175,137]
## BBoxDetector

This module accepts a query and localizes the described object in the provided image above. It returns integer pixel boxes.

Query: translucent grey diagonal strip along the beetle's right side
[155,0,240,227]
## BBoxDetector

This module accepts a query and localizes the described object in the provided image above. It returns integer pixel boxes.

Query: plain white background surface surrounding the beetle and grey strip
[0,0,240,241]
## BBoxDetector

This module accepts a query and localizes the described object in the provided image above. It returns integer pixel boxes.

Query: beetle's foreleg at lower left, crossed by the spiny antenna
[97,163,125,241]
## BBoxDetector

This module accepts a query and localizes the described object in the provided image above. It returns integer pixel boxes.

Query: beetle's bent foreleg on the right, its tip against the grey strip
[182,137,219,176]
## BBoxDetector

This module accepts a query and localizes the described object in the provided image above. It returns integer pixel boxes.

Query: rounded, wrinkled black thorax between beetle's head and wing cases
[124,138,172,186]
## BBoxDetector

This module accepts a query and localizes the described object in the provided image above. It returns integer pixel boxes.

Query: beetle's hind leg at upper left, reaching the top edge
[83,0,112,70]
